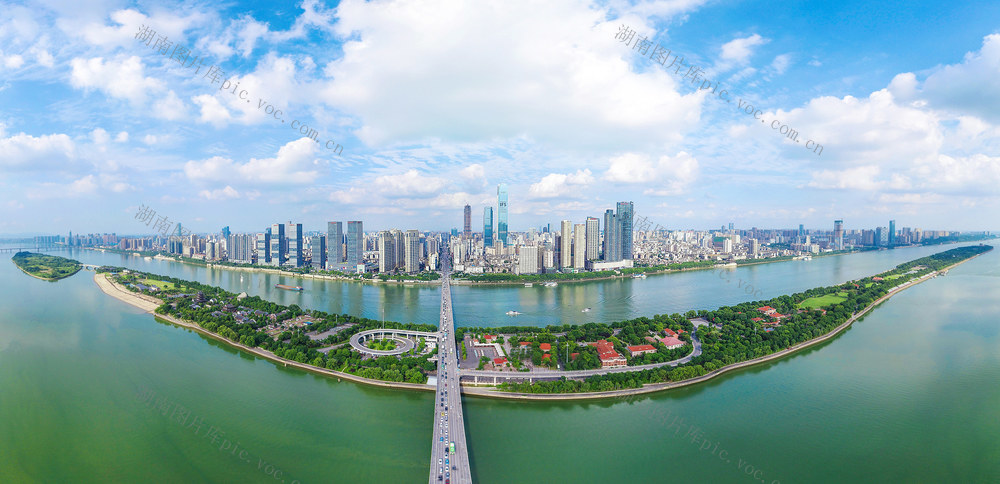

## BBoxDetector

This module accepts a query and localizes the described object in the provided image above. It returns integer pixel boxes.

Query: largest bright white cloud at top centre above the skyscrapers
[320,0,701,149]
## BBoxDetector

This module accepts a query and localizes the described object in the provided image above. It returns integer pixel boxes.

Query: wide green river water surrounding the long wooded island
[0,246,1000,483]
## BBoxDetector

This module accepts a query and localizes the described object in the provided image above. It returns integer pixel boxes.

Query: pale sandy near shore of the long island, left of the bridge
[94,273,435,392]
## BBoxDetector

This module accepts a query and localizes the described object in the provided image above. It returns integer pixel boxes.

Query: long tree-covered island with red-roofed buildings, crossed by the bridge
[92,245,992,398]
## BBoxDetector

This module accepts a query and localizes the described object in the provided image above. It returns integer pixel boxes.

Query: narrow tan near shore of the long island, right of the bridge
[462,250,982,400]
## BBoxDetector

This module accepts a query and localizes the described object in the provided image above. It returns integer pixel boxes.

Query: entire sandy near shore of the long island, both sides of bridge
[94,250,981,400]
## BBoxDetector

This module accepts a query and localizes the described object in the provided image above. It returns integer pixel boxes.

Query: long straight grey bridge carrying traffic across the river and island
[428,251,472,484]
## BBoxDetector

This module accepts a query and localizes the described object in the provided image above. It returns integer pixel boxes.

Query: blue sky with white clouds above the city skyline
[0,0,1000,234]
